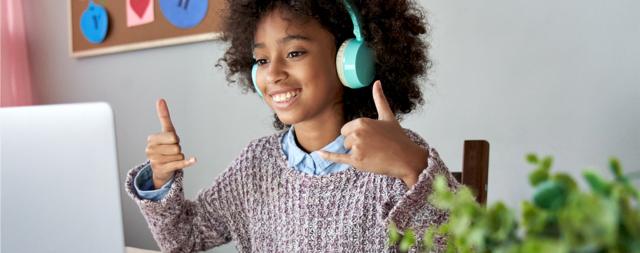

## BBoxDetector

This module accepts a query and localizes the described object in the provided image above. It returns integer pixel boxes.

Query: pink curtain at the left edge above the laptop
[0,0,33,107]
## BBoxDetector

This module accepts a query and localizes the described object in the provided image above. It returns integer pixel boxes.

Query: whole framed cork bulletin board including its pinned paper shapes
[68,0,226,57]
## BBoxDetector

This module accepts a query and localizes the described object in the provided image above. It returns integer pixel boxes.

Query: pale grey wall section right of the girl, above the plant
[406,0,640,206]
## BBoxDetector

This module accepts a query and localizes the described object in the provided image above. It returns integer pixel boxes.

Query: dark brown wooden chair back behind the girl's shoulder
[451,140,489,205]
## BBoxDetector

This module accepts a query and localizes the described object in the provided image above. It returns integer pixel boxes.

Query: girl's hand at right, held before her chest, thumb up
[319,80,428,186]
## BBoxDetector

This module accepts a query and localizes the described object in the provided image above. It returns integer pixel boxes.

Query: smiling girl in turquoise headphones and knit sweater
[126,0,457,252]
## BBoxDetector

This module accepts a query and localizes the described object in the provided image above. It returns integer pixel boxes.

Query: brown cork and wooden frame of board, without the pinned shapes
[67,0,226,58]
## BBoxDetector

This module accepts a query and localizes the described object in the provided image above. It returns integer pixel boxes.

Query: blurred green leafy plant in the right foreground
[389,154,640,253]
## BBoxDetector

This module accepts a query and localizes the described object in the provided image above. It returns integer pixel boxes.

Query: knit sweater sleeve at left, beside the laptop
[125,157,241,252]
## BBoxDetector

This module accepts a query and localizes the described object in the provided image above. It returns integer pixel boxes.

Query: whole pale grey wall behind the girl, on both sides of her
[25,0,640,252]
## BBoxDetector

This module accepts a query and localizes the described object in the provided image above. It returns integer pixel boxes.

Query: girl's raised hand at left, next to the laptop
[145,99,196,189]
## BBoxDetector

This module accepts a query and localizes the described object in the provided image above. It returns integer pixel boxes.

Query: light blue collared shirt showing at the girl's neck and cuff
[134,126,351,201]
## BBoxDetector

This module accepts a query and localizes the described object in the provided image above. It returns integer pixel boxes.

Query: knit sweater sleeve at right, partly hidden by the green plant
[387,130,459,252]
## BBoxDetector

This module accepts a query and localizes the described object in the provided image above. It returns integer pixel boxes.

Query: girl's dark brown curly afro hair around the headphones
[217,0,432,130]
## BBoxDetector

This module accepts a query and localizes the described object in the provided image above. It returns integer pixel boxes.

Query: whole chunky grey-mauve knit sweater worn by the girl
[126,130,458,252]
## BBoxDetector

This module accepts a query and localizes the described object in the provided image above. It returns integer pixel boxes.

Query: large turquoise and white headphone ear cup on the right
[336,39,375,89]
